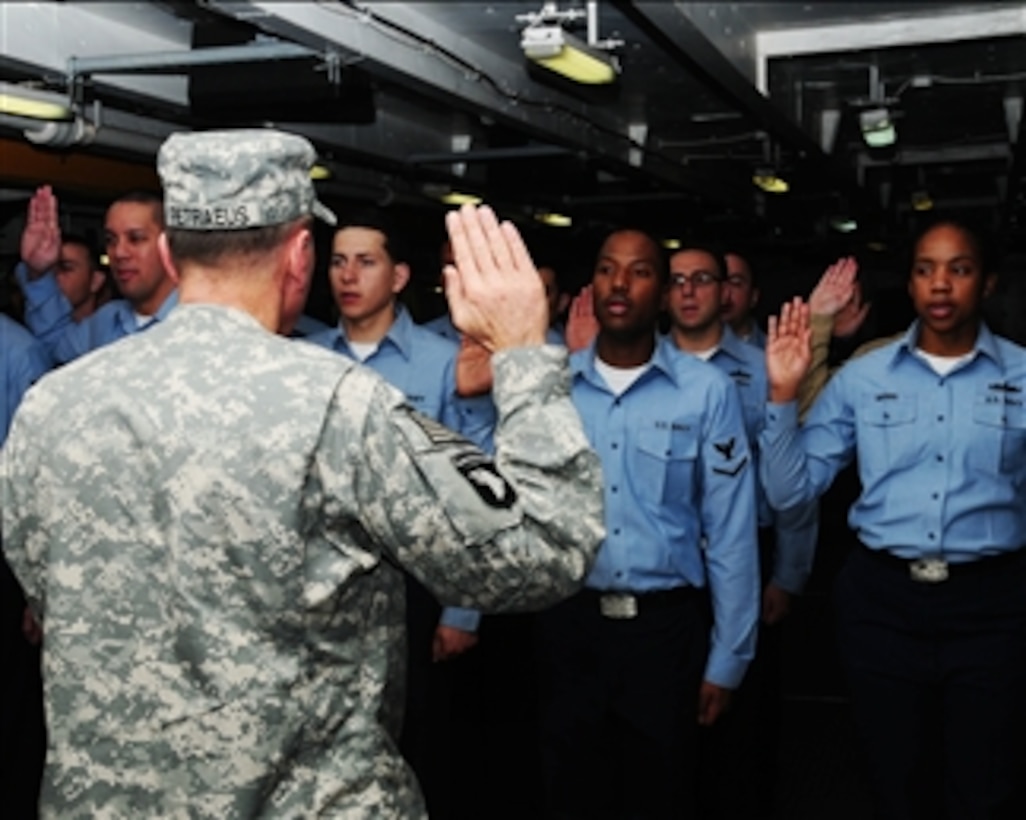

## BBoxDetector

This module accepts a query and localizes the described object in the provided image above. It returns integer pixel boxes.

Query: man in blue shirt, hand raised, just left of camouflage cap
[15,187,177,364]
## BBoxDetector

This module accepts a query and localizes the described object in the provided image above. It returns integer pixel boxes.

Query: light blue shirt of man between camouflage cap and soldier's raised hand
[303,304,496,632]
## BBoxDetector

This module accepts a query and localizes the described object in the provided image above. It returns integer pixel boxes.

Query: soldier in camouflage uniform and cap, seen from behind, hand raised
[0,130,603,818]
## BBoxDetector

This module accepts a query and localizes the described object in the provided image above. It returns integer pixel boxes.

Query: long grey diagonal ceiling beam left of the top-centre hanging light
[198,0,750,204]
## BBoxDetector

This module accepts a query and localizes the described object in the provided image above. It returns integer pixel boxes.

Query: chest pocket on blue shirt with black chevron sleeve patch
[631,422,699,508]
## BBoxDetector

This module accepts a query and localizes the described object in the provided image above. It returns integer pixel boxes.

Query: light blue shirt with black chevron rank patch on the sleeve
[570,340,759,689]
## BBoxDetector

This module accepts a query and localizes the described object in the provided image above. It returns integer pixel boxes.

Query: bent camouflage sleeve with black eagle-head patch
[315,347,604,611]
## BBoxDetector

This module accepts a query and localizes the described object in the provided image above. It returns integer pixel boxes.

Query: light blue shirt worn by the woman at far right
[761,323,1026,563]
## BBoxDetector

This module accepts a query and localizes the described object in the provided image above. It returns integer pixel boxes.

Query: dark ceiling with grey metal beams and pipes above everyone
[6,0,1026,256]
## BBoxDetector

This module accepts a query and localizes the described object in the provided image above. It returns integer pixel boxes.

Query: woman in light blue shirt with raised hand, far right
[760,219,1026,818]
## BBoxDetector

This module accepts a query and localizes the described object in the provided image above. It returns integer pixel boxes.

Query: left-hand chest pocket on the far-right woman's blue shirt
[858,394,921,473]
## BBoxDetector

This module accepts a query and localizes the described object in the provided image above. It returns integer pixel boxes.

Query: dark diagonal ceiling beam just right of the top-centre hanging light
[614,0,861,196]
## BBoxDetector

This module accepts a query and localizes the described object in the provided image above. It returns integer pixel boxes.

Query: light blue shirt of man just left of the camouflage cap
[14,263,179,364]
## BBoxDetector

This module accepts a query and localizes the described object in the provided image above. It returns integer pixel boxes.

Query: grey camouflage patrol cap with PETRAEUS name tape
[157,128,337,231]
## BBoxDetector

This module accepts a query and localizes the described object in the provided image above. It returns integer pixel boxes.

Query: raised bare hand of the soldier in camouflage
[444,205,549,352]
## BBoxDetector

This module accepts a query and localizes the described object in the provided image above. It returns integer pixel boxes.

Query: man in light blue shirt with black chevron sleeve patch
[538,230,759,817]
